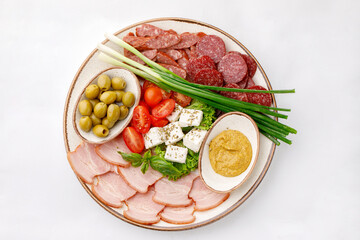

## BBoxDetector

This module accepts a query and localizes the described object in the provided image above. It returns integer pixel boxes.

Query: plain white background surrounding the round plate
[0,0,360,240]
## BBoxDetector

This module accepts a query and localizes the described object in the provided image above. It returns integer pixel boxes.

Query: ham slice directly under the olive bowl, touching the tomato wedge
[95,134,131,167]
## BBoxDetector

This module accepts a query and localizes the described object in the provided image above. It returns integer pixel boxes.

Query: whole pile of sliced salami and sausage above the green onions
[123,24,272,106]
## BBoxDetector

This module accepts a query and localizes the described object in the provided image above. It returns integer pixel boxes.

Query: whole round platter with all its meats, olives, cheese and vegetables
[64,18,296,231]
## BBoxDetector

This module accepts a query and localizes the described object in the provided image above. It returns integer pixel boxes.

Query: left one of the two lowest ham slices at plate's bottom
[124,188,164,225]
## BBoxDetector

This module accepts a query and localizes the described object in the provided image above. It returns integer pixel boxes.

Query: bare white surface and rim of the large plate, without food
[64,18,276,231]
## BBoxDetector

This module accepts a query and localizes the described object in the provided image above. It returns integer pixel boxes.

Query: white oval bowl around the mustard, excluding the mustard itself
[199,112,260,192]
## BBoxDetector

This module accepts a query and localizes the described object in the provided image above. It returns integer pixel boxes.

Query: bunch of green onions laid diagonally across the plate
[98,34,297,145]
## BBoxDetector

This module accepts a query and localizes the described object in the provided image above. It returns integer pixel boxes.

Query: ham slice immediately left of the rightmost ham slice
[153,172,198,207]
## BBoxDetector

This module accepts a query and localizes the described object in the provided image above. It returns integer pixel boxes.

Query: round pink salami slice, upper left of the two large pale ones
[196,35,226,63]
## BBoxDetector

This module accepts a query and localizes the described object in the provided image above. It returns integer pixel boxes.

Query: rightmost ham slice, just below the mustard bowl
[189,177,230,211]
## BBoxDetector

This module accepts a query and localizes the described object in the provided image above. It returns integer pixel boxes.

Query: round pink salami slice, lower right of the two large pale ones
[218,53,248,83]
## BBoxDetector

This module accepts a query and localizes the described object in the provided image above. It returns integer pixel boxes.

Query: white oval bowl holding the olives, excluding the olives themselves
[73,67,141,144]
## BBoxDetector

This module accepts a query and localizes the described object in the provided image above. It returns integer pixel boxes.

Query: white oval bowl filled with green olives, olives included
[73,67,141,144]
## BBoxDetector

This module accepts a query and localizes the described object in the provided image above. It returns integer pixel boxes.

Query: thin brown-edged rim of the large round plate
[63,17,277,231]
